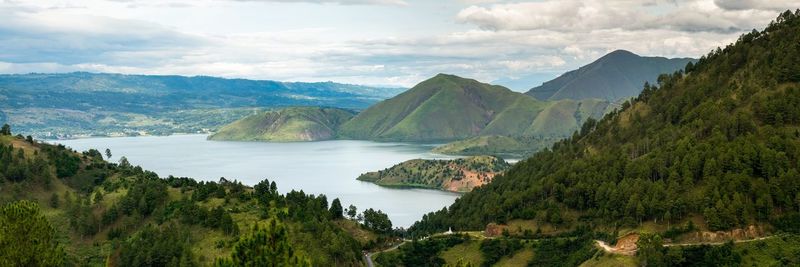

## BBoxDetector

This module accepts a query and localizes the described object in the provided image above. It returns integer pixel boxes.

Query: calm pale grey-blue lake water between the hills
[56,135,459,227]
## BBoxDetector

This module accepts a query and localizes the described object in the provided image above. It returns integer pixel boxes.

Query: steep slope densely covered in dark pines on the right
[411,10,800,239]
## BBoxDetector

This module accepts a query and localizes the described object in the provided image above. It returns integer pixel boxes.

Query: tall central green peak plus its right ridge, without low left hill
[339,74,610,141]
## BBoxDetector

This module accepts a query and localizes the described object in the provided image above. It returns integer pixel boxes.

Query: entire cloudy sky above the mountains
[0,0,800,91]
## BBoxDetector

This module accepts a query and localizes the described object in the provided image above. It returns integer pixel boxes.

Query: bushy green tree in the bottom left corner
[0,200,65,266]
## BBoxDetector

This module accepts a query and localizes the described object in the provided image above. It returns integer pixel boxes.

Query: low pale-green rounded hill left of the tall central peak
[208,107,354,142]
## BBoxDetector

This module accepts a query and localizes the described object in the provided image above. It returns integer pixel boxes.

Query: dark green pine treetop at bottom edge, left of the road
[215,221,311,267]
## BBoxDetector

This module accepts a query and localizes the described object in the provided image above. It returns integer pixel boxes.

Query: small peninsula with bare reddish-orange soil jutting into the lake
[357,156,510,192]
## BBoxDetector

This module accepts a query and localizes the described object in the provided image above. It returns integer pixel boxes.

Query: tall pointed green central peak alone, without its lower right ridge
[340,74,543,141]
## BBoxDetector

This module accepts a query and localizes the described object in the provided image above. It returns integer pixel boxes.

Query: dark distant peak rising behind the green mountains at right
[526,50,693,101]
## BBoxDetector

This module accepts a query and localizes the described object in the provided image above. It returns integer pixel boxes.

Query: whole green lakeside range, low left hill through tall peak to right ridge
[210,74,615,155]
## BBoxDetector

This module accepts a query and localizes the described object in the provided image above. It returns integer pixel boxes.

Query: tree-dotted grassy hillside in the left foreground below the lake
[0,125,393,266]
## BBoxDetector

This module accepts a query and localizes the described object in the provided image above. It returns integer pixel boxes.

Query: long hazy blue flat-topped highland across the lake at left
[0,72,404,139]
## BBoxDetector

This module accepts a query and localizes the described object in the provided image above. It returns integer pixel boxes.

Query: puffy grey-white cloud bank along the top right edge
[456,0,791,32]
